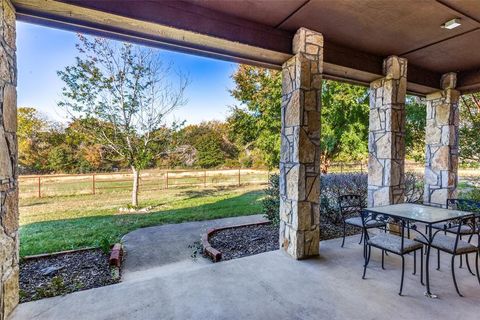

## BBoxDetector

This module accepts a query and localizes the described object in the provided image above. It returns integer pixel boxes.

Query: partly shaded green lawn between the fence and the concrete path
[20,186,263,256]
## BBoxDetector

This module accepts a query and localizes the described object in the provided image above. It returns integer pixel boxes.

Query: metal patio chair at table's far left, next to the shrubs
[338,194,386,248]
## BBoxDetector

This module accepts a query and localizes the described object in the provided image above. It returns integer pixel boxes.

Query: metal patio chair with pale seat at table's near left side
[361,211,423,296]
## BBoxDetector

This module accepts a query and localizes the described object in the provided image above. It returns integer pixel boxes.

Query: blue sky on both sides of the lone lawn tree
[17,22,237,124]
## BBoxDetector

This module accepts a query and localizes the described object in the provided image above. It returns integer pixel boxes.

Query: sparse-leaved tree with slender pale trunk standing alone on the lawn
[58,35,188,207]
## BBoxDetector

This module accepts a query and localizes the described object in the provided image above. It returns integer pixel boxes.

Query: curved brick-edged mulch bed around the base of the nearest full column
[209,219,360,260]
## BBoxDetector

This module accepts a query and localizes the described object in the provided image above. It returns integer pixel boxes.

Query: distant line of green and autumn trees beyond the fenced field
[18,65,480,173]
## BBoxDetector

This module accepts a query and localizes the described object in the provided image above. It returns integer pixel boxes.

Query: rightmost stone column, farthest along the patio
[423,73,460,207]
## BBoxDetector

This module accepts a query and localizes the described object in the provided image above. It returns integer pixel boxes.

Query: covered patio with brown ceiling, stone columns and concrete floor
[0,0,480,319]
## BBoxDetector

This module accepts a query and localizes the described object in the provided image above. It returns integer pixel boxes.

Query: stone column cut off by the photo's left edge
[0,0,19,319]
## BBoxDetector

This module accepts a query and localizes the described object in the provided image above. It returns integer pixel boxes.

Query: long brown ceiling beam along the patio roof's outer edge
[12,0,440,95]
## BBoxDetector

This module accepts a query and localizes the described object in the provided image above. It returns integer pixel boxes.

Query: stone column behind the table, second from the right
[368,56,407,207]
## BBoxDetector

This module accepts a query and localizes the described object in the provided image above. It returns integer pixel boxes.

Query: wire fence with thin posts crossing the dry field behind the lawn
[19,169,271,198]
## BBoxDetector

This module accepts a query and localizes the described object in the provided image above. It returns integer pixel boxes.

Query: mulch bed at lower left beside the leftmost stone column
[20,249,119,302]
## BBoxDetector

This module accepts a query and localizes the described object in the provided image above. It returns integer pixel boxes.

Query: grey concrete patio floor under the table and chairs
[11,226,480,320]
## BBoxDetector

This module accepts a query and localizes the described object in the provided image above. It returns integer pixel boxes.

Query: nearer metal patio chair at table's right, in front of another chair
[415,217,480,297]
